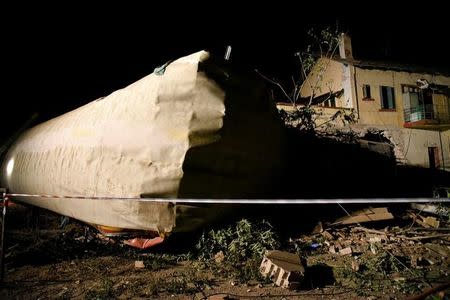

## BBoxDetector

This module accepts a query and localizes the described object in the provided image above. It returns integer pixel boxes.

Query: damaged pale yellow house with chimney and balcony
[278,34,450,171]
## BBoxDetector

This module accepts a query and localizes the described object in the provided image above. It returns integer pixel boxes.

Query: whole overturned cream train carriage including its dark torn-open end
[2,51,286,245]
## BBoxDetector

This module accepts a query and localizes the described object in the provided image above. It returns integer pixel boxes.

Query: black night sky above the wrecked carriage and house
[0,1,450,139]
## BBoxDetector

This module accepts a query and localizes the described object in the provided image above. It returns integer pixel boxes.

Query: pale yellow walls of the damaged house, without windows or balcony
[301,60,450,171]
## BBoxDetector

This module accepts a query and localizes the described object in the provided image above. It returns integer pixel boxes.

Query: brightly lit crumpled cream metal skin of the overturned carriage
[3,51,225,232]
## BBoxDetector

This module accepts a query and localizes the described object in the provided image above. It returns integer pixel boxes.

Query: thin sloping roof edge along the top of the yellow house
[334,57,450,76]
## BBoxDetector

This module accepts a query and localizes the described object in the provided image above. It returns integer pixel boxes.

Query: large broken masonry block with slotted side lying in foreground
[260,250,305,289]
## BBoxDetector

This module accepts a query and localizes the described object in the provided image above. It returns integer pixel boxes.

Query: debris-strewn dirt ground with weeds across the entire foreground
[0,203,450,299]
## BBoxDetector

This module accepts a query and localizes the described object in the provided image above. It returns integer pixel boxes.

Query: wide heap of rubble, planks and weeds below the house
[290,208,450,295]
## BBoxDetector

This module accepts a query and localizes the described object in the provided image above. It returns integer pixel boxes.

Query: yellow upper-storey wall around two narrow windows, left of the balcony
[355,67,450,127]
